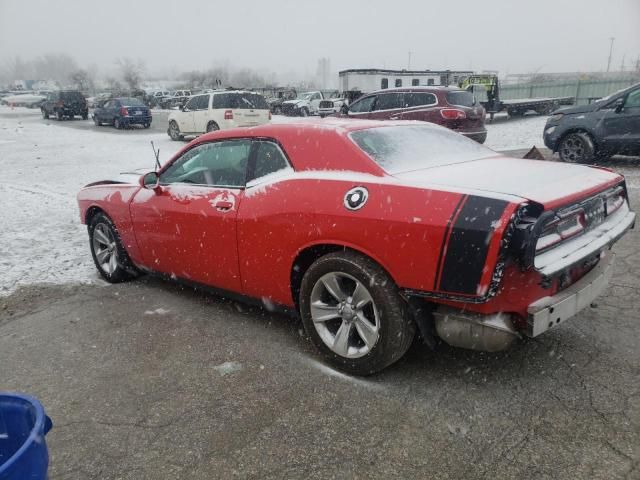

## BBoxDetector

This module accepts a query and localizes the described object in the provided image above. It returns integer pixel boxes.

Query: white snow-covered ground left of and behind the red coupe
[0,106,545,296]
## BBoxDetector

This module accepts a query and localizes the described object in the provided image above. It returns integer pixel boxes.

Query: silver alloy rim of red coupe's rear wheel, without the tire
[310,272,380,358]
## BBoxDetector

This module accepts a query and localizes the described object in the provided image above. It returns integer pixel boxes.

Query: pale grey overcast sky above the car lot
[0,0,640,74]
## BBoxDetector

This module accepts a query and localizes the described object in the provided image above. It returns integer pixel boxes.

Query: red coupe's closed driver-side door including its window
[130,140,251,292]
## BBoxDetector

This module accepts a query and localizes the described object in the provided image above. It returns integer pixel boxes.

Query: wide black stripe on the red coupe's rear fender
[439,195,508,295]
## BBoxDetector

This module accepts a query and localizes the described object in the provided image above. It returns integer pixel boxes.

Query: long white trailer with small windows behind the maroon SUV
[338,68,473,93]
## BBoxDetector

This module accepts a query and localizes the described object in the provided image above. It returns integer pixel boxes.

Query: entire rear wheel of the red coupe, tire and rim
[299,251,415,375]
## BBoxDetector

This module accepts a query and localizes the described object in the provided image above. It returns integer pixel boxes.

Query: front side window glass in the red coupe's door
[160,140,251,188]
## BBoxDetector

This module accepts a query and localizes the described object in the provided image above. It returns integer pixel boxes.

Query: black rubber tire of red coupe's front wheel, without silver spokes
[88,213,138,283]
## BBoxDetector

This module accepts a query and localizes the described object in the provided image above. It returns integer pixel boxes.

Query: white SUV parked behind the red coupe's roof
[167,90,271,140]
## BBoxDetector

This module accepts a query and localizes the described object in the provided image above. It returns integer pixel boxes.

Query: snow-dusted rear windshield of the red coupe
[350,125,496,174]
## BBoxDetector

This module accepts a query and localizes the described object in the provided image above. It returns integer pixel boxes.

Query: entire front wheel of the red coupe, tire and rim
[89,213,137,283]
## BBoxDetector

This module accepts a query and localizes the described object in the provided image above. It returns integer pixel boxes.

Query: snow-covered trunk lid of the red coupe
[394,156,622,208]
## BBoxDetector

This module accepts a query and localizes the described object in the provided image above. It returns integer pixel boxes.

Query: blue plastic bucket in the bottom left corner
[0,392,52,480]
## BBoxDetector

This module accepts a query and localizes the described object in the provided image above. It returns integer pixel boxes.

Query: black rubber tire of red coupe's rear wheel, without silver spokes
[299,251,416,375]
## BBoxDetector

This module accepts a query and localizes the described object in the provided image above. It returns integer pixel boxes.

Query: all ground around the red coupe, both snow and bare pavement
[0,109,640,480]
